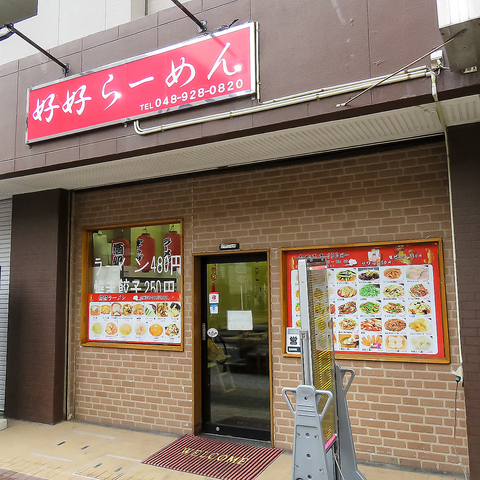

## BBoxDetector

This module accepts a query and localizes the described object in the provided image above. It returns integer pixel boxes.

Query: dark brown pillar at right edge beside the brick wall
[449,123,480,479]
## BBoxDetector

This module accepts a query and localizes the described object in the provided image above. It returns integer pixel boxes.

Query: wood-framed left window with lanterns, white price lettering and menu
[82,221,183,350]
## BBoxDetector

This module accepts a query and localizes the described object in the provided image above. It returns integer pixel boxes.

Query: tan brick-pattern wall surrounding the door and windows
[70,143,467,472]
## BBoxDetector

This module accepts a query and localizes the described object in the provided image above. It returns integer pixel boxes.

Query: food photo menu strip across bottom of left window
[88,293,182,345]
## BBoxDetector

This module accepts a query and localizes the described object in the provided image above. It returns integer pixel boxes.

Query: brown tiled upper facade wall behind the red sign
[0,0,480,176]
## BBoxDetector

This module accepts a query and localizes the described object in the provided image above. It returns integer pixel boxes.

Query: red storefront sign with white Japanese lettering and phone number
[26,23,256,143]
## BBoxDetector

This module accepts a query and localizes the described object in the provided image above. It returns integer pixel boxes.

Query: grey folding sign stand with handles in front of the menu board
[282,259,366,480]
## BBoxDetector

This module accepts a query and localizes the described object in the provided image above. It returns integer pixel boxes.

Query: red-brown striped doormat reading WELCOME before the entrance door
[142,435,283,480]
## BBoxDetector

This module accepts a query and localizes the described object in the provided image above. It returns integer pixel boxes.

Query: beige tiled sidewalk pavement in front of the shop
[0,420,464,480]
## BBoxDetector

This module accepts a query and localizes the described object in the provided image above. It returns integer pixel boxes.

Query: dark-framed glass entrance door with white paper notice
[202,253,270,440]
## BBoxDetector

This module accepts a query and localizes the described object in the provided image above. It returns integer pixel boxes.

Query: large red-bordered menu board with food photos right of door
[282,239,450,363]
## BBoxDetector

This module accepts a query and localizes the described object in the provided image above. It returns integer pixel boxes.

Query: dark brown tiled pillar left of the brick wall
[5,190,69,424]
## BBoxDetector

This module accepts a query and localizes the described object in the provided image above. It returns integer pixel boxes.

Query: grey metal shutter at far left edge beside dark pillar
[0,200,12,411]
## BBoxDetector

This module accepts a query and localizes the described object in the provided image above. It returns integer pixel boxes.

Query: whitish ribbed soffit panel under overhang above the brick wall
[0,95,480,199]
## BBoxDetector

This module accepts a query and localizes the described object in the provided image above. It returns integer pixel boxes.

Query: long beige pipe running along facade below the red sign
[133,66,429,135]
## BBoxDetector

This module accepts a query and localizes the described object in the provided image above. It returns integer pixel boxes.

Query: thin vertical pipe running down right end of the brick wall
[430,54,463,374]
